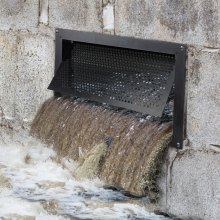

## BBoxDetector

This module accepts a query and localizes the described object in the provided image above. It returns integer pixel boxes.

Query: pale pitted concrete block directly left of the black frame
[14,32,54,125]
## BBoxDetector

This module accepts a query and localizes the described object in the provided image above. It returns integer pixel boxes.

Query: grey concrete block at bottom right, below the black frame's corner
[160,149,220,220]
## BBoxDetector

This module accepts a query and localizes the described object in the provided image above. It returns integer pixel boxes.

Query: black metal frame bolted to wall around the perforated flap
[51,29,186,149]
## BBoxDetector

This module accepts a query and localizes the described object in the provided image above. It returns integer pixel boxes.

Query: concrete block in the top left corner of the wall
[0,0,39,30]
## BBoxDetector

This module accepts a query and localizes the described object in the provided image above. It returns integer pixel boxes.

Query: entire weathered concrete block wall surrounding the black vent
[0,0,220,220]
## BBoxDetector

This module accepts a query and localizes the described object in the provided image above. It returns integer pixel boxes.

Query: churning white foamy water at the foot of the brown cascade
[0,131,171,220]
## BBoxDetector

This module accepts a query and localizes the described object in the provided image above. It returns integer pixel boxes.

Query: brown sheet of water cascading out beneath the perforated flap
[32,98,172,201]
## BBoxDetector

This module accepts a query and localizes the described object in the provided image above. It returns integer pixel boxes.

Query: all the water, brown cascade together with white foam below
[0,98,172,220]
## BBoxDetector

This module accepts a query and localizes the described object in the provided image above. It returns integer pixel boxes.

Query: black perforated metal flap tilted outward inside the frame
[49,42,175,116]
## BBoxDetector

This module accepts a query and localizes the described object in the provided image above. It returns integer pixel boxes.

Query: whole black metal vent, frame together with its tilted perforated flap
[49,29,186,148]
